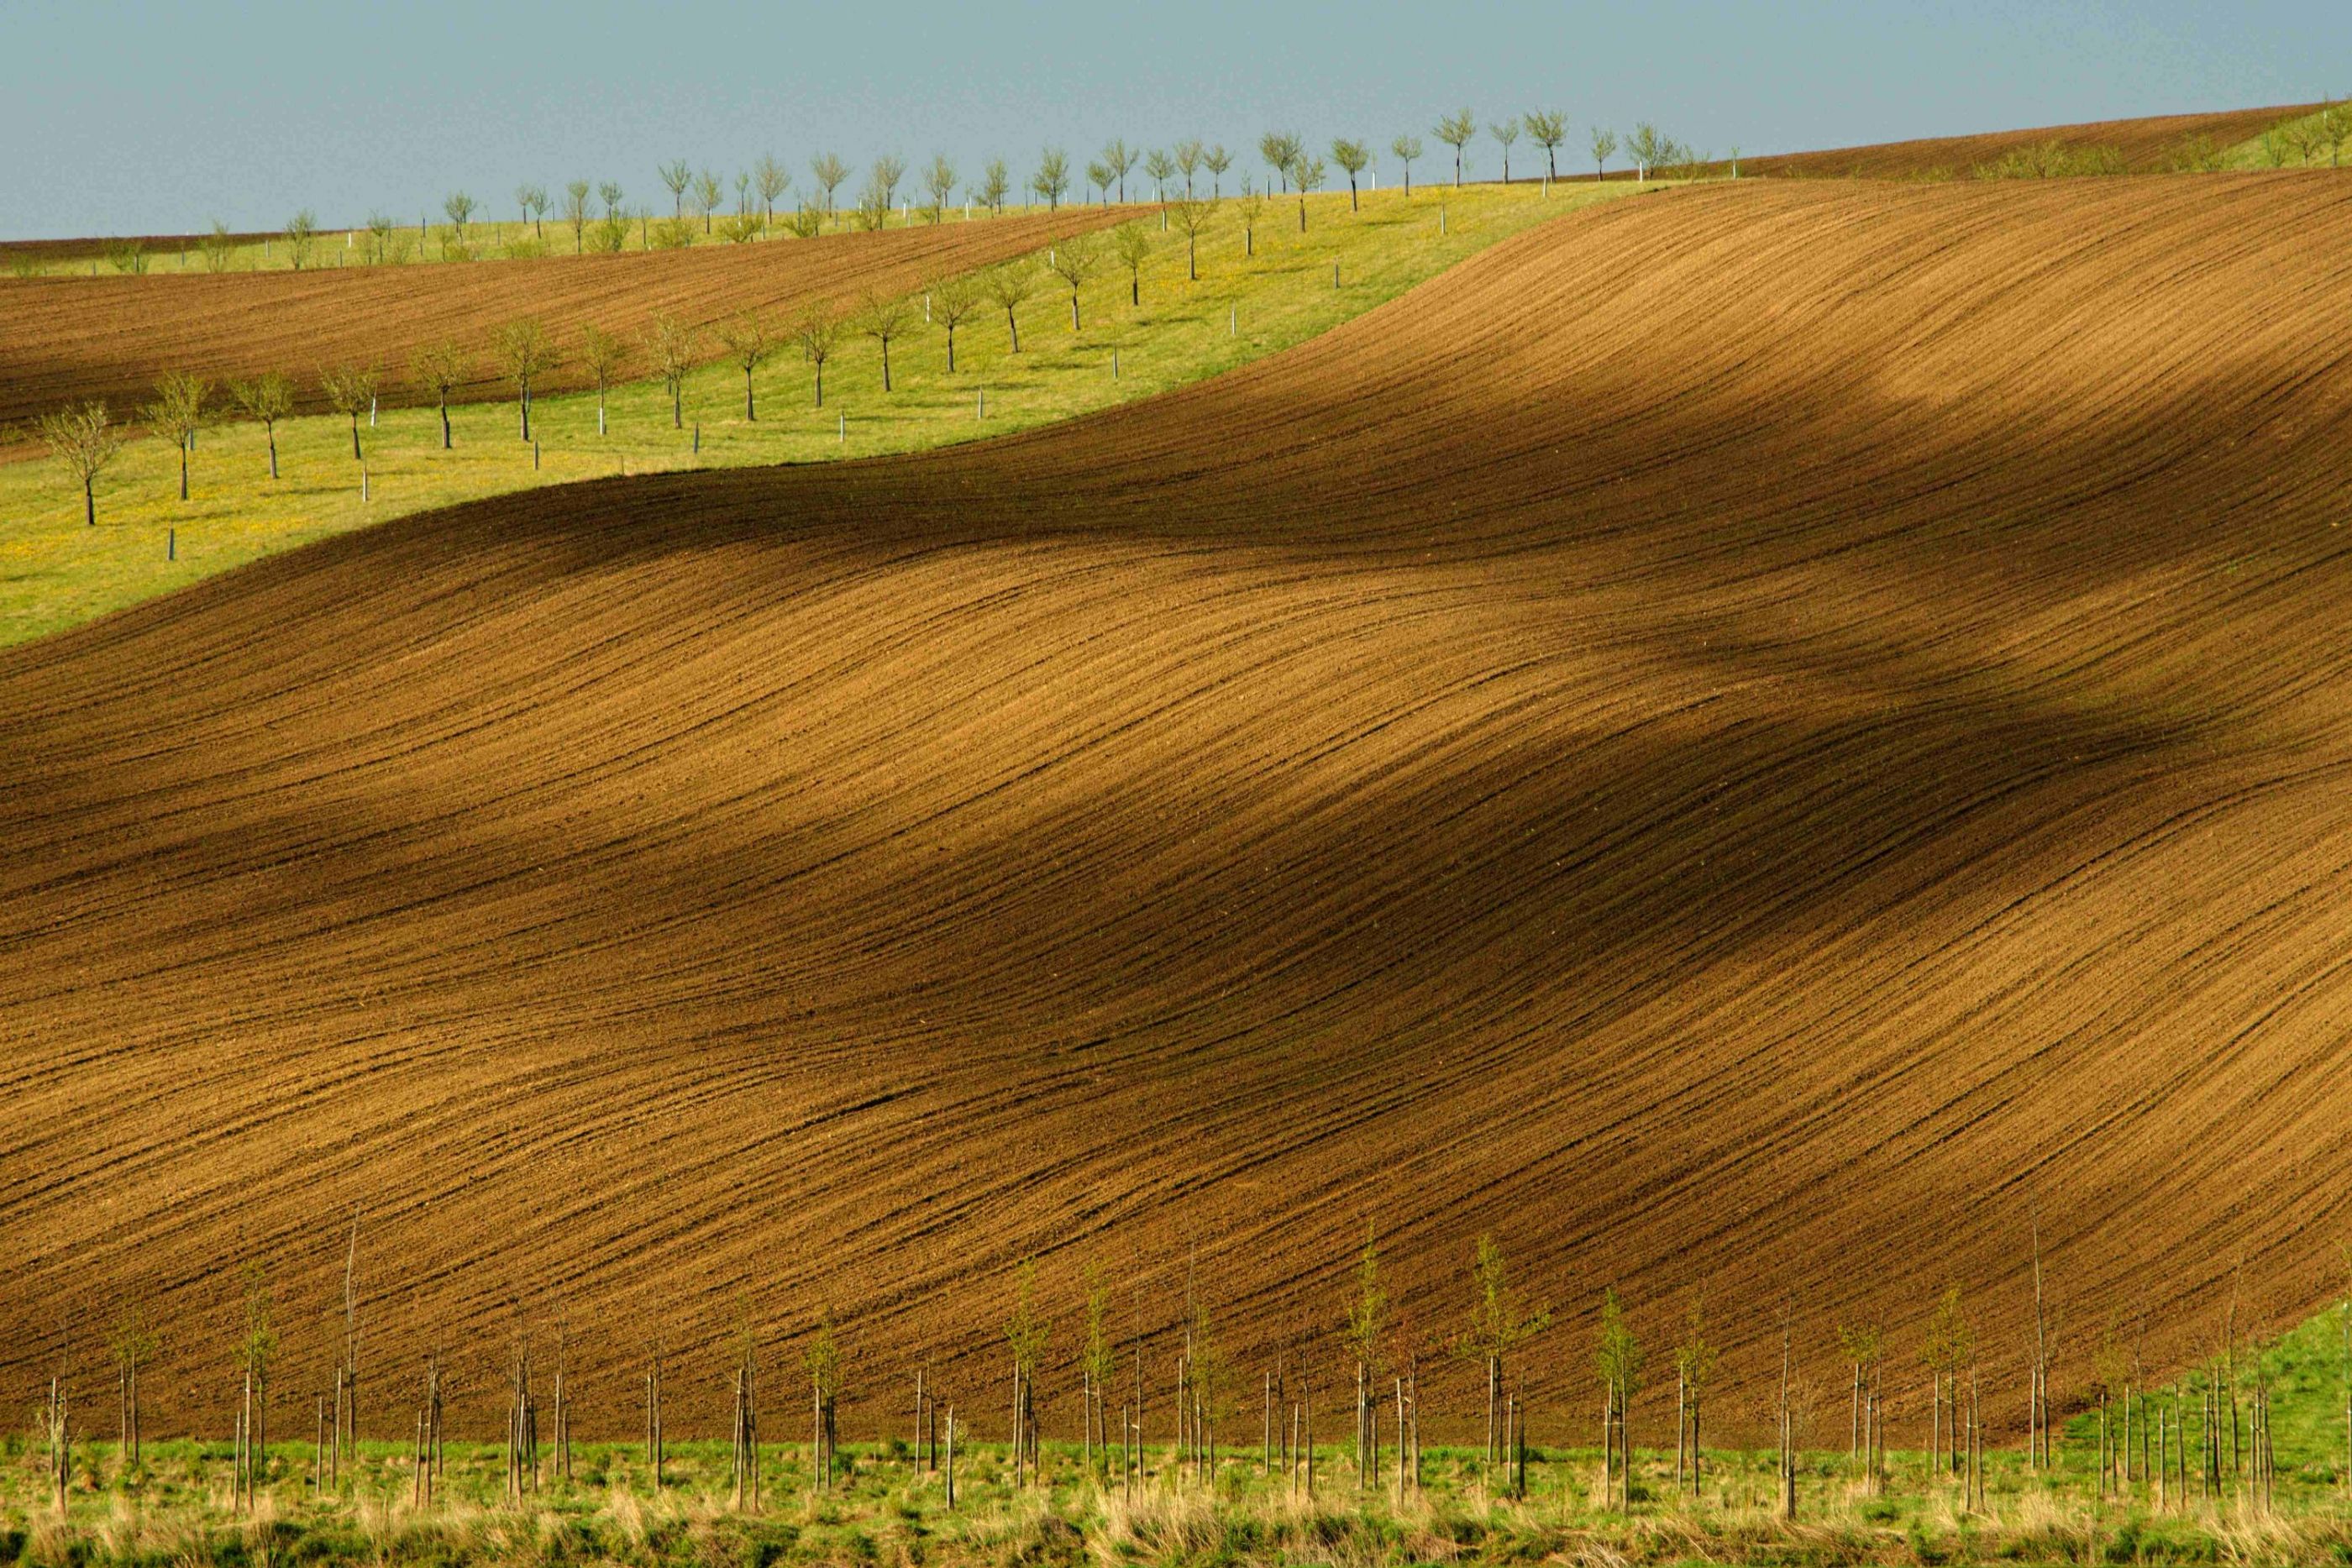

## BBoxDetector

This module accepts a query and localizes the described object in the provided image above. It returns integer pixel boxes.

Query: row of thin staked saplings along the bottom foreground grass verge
[27,1223,2352,1518]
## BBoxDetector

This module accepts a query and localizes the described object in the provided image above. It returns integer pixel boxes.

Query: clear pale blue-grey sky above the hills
[0,0,2352,238]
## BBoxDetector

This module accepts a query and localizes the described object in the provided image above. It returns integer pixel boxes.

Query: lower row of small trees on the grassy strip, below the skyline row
[33,201,1345,527]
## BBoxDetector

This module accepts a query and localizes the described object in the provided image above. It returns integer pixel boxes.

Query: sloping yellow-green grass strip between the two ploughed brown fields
[0,183,1661,644]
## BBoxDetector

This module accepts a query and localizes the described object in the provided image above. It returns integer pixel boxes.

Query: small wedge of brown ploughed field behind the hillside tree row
[0,207,1129,423]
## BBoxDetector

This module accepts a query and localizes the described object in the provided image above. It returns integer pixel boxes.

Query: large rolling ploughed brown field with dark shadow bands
[0,176,2352,1439]
